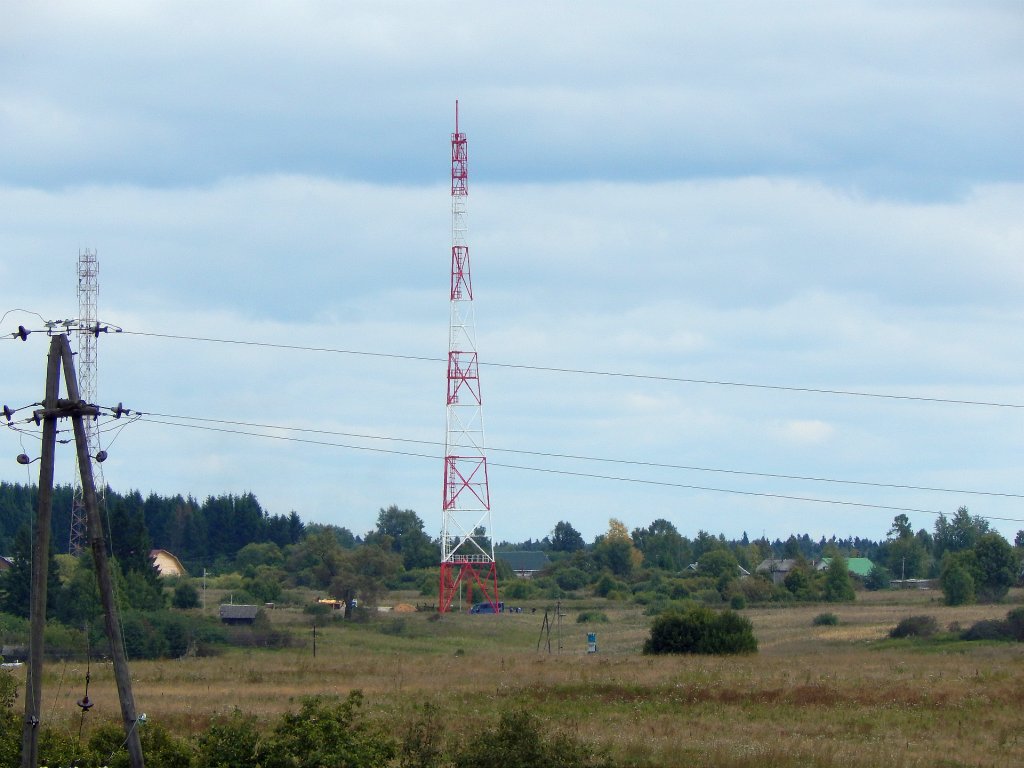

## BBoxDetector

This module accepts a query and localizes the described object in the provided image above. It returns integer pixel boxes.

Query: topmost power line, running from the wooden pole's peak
[116,331,1024,409]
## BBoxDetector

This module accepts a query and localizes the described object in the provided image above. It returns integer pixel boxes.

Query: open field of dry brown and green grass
[16,590,1024,766]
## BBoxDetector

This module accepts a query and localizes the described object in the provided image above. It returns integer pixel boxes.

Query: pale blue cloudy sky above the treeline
[0,0,1024,541]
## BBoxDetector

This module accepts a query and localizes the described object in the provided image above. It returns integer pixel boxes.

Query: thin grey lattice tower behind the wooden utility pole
[68,248,105,555]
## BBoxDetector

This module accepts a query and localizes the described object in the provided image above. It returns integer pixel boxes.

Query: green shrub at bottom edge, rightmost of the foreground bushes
[450,710,610,768]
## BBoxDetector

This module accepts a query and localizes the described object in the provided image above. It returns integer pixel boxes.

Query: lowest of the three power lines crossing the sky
[132,415,1024,522]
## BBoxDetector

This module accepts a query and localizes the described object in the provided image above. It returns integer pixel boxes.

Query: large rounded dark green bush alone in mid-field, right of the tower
[643,606,758,654]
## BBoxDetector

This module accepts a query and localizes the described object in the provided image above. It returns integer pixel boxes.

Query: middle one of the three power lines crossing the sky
[136,412,1024,499]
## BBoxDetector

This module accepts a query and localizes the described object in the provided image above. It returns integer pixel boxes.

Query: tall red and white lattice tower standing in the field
[438,101,498,613]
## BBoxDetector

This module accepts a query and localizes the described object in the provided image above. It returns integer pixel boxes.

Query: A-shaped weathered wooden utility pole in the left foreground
[22,334,144,768]
